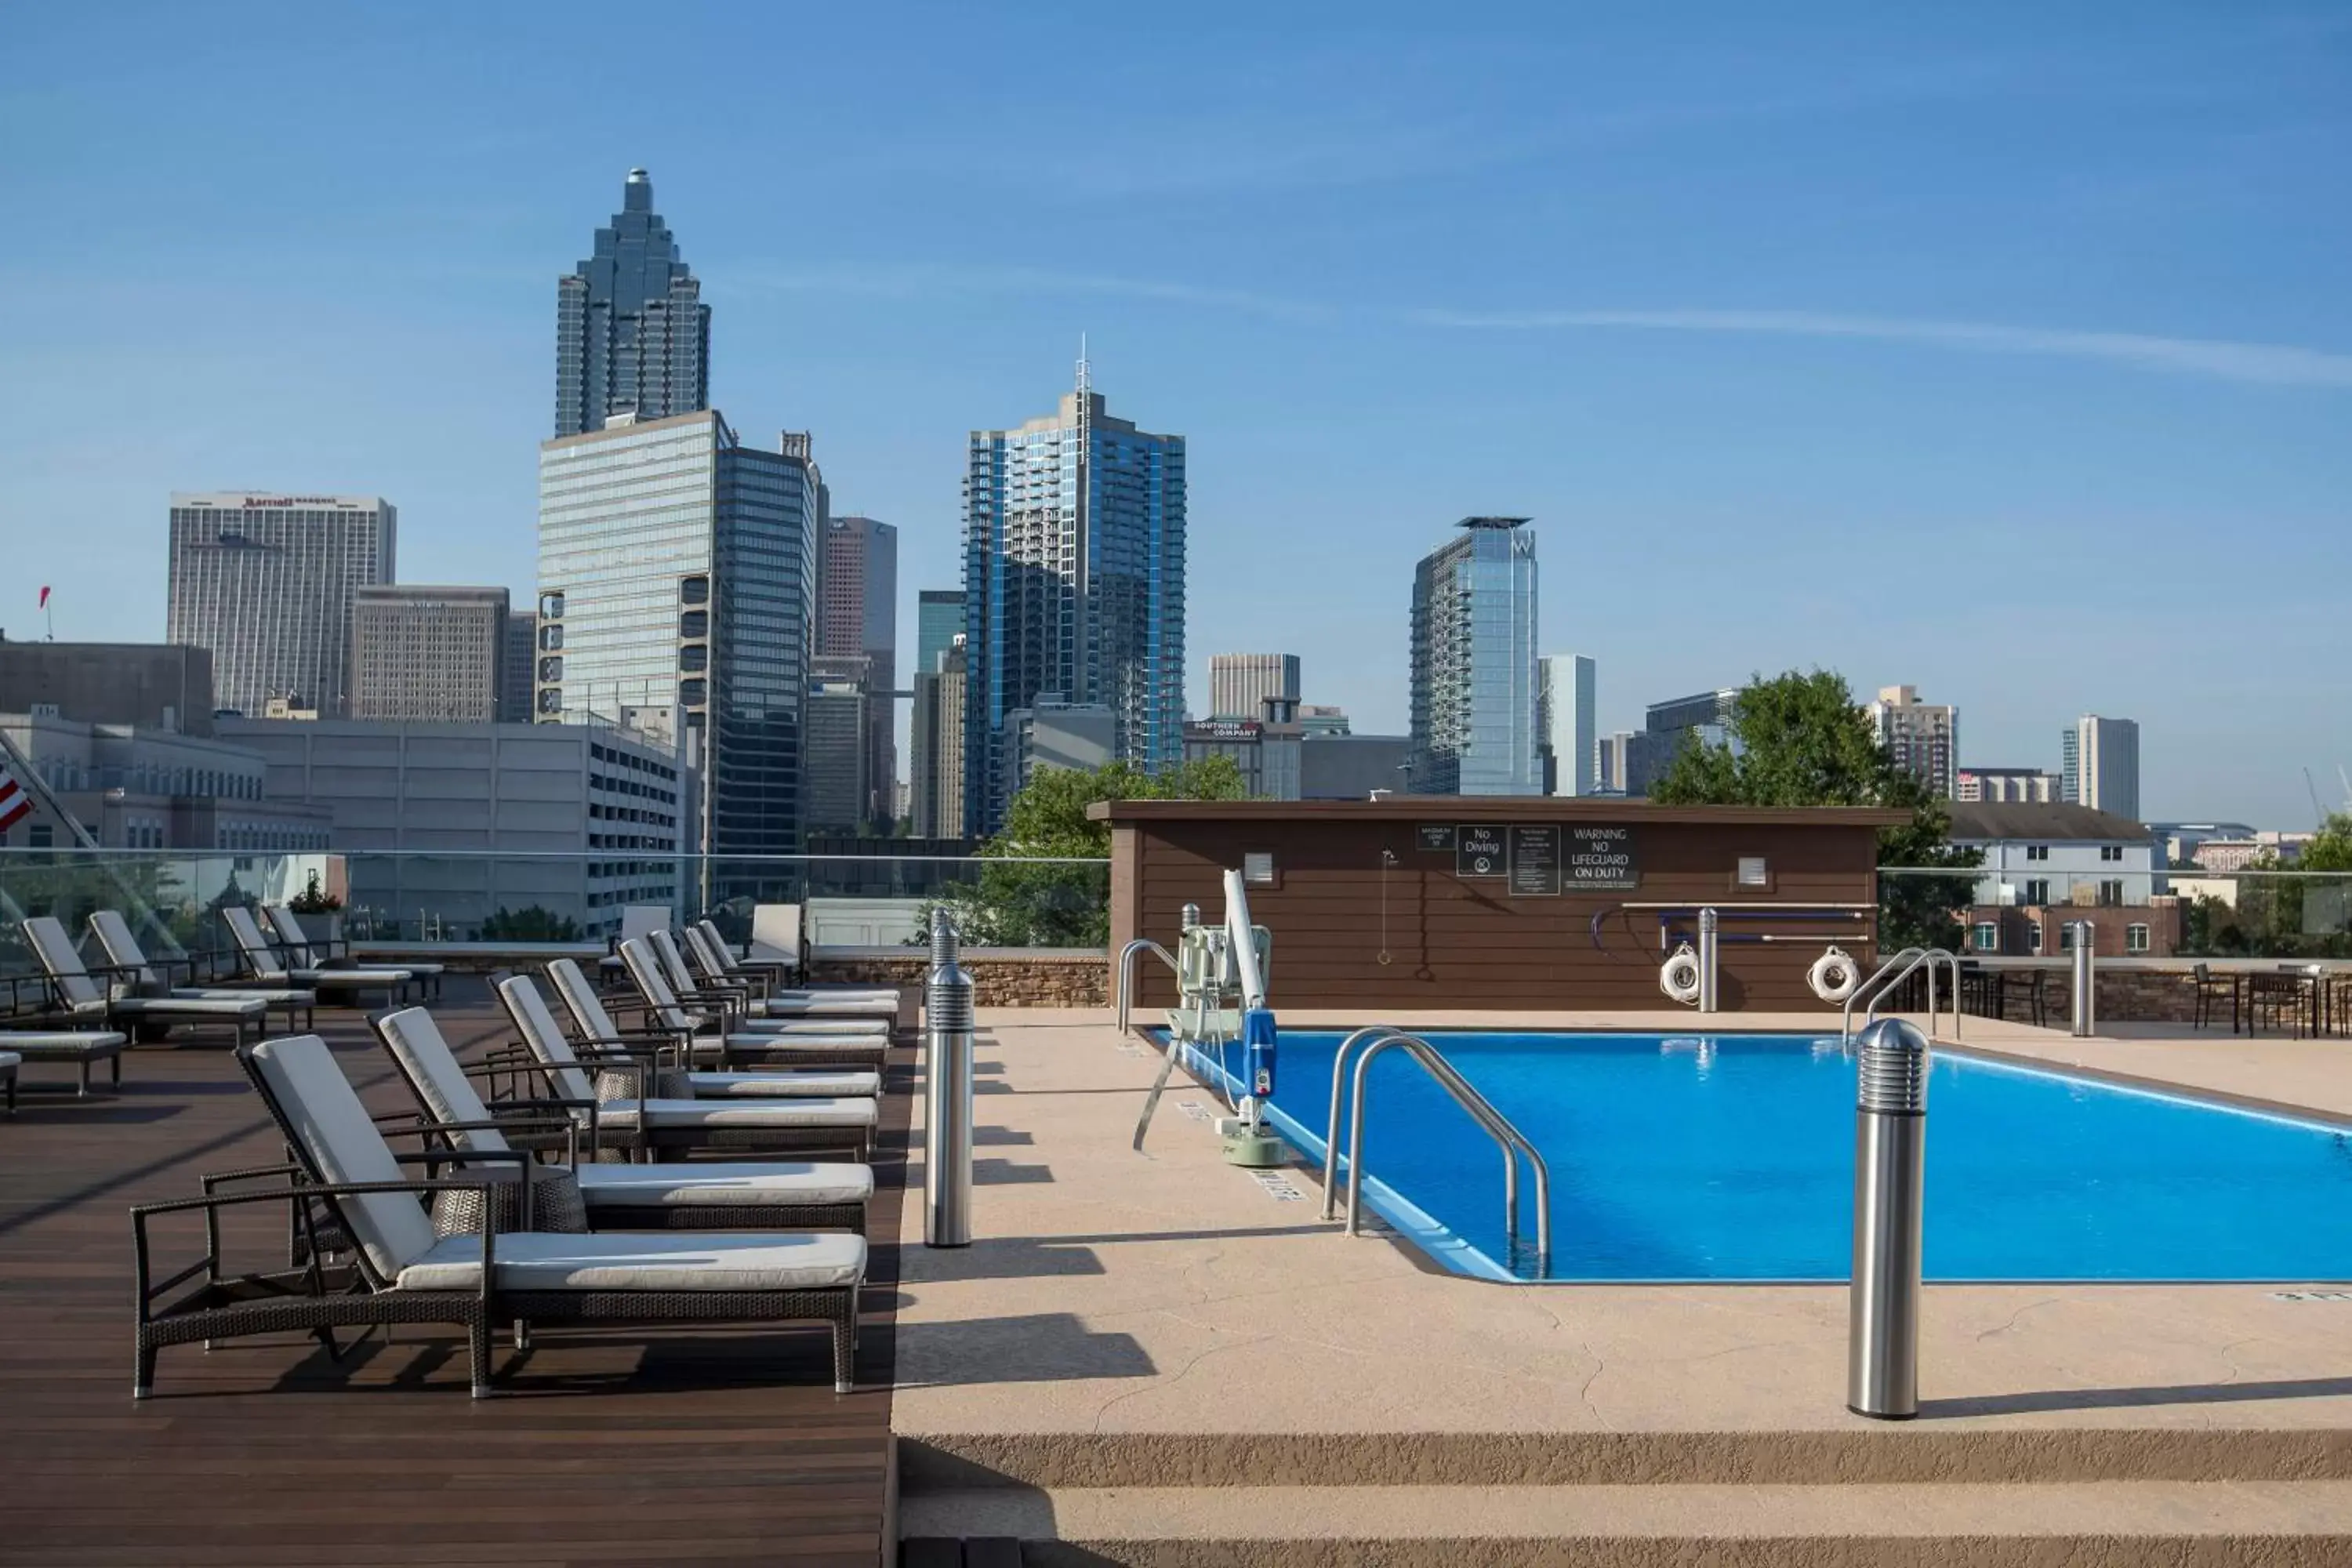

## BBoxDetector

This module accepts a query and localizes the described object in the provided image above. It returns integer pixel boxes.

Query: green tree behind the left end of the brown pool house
[917,757,1247,947]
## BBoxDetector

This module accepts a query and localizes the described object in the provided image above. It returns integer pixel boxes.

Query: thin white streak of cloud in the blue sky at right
[1411,310,2352,388]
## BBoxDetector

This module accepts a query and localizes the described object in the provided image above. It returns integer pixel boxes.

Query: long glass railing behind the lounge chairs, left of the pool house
[0,848,1110,973]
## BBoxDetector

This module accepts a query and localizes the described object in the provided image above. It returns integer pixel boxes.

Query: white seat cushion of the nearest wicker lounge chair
[400,1232,866,1290]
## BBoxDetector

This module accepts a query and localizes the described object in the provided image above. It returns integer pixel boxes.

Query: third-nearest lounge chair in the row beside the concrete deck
[492,975,880,1161]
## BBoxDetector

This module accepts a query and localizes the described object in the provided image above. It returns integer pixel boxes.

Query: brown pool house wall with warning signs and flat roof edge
[1096,799,1900,1018]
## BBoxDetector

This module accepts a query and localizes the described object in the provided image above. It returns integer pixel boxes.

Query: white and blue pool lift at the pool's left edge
[1134,869,1282,1168]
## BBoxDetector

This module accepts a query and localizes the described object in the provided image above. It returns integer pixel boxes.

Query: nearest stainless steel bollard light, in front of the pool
[1846,1018,1926,1420]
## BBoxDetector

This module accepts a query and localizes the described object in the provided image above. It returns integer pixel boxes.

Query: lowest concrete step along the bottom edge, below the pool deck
[898,1481,2352,1568]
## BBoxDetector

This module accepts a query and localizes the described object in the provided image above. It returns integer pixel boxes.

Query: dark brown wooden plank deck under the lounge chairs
[0,975,913,1568]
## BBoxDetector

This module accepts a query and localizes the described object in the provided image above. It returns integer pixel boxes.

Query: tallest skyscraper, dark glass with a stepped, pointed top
[555,169,710,437]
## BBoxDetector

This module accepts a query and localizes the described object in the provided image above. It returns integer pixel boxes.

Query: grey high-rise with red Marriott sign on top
[165,492,397,717]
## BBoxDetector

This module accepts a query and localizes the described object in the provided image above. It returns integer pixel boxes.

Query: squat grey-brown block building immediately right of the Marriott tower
[348,583,508,724]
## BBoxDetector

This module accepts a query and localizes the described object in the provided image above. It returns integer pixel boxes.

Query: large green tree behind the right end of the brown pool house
[1649,670,1980,949]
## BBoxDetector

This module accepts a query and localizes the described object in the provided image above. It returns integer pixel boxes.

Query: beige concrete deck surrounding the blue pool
[891,1008,2352,1561]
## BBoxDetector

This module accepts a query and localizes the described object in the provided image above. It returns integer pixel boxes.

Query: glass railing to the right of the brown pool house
[1879,862,2352,959]
